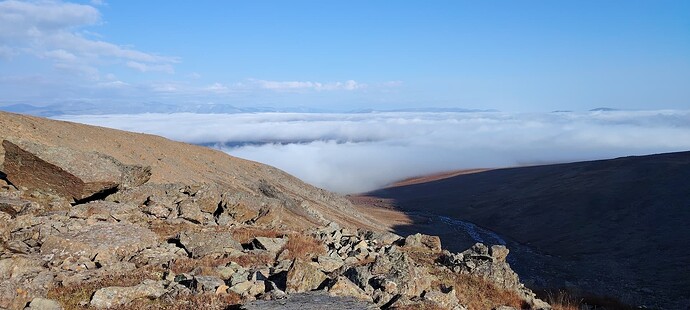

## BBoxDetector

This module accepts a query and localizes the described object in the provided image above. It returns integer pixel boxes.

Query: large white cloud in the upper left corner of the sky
[0,0,178,73]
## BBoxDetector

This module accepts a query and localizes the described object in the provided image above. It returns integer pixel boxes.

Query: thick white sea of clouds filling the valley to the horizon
[56,110,690,193]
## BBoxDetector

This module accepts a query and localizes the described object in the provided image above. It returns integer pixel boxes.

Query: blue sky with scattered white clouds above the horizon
[0,0,690,112]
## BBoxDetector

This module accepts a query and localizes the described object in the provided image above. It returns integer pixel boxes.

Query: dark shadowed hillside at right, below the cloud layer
[368,152,690,309]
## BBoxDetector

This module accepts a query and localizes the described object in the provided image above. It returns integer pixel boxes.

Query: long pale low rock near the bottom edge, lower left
[89,280,167,308]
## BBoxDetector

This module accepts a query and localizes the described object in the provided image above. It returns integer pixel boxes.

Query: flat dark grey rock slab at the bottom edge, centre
[240,292,379,310]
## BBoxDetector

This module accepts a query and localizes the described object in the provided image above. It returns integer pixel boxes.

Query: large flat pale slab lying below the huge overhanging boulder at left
[41,222,158,264]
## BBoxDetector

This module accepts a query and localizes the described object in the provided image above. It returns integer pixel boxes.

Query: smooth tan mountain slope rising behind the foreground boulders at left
[0,112,375,229]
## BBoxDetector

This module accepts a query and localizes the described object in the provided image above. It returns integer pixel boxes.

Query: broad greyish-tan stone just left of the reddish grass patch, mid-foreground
[178,231,242,258]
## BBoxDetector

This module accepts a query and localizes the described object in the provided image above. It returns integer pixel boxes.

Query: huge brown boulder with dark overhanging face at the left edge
[2,140,151,201]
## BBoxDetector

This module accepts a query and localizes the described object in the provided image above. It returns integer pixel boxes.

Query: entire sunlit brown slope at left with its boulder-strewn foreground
[0,113,551,309]
